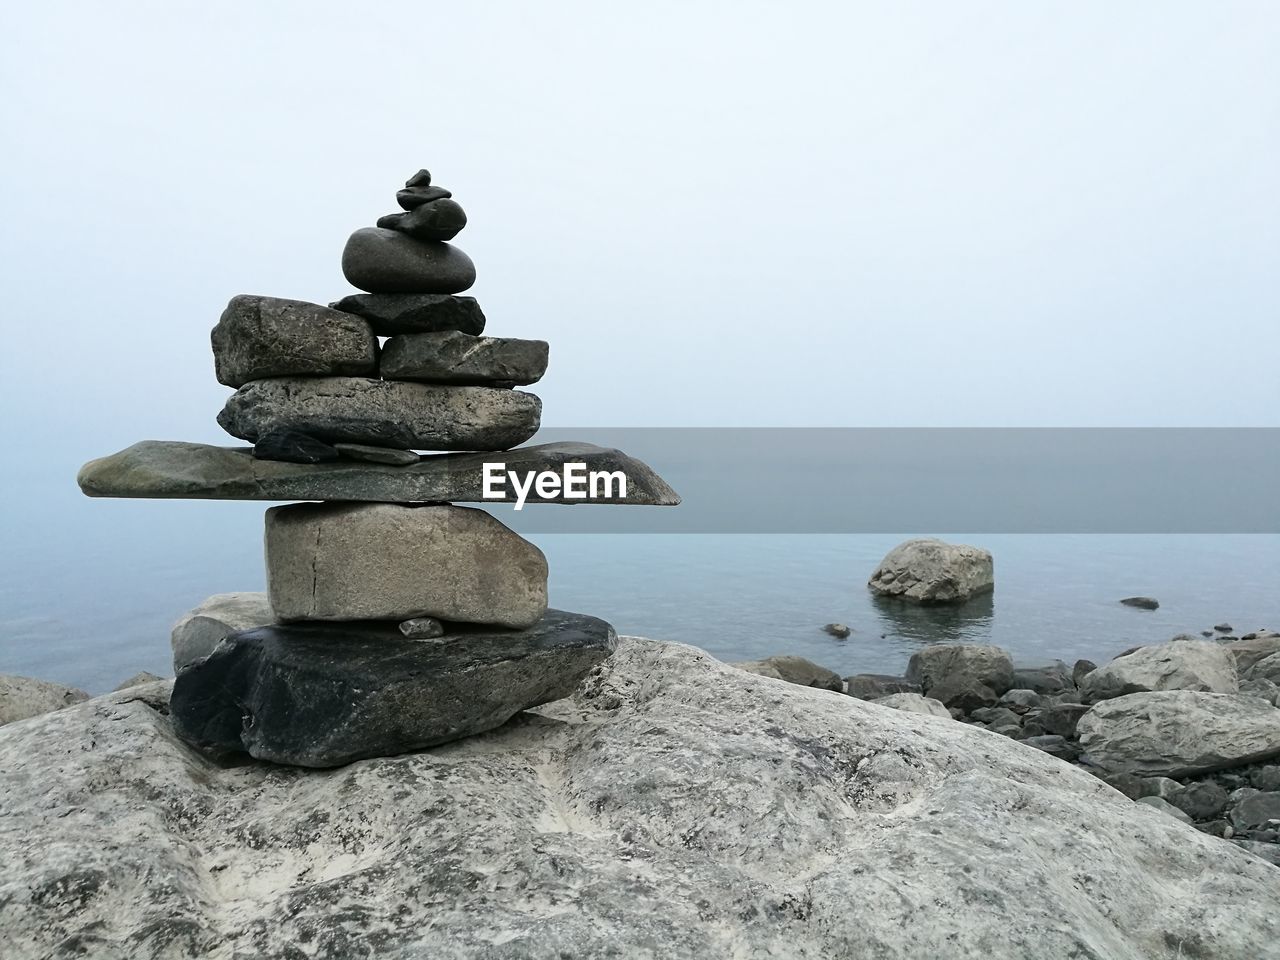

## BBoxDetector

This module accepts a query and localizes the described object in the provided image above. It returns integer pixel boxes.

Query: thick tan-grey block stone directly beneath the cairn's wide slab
[266,503,547,628]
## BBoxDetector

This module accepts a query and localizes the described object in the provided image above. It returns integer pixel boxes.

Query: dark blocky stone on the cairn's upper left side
[211,296,378,387]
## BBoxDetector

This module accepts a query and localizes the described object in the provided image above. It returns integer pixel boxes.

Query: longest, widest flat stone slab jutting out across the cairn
[77,440,680,507]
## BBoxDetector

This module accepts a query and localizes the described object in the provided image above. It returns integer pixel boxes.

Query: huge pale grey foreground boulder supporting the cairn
[0,637,1280,960]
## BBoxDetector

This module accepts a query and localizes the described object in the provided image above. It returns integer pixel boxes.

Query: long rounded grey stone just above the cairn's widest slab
[218,376,543,451]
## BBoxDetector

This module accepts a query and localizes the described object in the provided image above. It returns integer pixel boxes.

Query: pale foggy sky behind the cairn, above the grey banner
[0,0,1280,484]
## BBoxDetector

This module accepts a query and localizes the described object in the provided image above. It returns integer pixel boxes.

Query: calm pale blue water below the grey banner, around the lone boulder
[0,497,1280,692]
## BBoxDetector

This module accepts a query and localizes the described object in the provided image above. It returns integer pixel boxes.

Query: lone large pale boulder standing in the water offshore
[868,540,995,603]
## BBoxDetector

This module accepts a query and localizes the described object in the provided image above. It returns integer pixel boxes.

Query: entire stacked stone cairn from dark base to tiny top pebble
[79,170,678,767]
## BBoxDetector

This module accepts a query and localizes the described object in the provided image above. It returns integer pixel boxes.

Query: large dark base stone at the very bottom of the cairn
[169,611,617,767]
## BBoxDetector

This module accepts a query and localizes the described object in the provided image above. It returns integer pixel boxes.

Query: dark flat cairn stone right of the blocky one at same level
[379,330,548,385]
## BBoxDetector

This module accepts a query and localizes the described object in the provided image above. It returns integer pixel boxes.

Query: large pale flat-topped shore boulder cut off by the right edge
[1078,690,1280,778]
